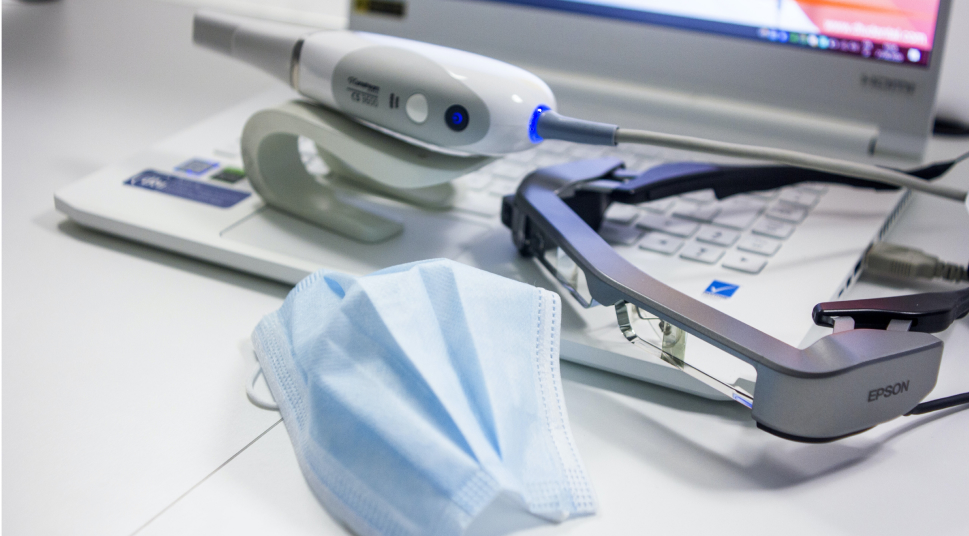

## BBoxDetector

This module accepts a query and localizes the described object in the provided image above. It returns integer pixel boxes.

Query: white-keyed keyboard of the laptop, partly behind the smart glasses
[455,141,827,274]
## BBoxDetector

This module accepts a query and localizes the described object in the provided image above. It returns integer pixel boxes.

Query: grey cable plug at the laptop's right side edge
[864,242,969,283]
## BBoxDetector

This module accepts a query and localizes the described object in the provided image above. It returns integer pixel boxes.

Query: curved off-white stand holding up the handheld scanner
[242,100,492,243]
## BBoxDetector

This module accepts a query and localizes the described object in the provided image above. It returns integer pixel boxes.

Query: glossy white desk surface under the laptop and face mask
[3,0,969,536]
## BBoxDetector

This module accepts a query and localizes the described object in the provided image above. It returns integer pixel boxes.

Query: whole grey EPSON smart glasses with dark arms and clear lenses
[502,158,969,443]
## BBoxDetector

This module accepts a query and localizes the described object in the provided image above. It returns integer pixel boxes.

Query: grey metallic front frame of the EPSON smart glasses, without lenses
[502,158,942,443]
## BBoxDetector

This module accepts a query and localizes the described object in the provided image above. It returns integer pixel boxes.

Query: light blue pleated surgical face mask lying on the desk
[252,260,596,535]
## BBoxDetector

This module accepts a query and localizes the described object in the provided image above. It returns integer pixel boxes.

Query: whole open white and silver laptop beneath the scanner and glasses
[55,0,949,399]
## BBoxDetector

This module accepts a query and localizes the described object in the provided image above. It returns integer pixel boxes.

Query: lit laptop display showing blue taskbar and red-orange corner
[480,0,939,67]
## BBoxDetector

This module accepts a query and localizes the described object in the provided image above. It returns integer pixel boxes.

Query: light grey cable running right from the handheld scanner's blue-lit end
[615,128,967,203]
